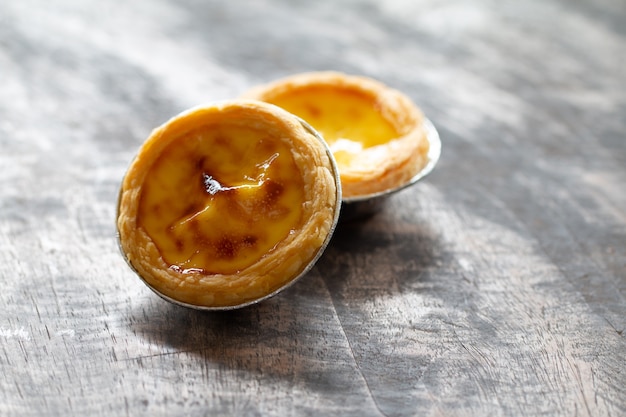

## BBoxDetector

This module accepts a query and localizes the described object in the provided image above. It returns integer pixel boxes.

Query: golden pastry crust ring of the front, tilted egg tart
[117,100,341,308]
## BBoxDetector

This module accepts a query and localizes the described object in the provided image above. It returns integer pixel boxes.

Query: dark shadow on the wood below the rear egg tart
[316,207,445,303]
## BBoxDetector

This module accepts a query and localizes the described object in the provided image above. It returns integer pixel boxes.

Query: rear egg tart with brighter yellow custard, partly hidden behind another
[243,72,429,199]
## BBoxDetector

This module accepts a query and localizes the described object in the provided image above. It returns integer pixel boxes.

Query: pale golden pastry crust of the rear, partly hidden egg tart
[243,72,429,199]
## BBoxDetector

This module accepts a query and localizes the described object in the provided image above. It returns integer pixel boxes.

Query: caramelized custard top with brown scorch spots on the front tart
[138,124,304,274]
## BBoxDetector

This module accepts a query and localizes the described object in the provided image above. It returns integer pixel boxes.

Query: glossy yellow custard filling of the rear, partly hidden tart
[268,86,399,171]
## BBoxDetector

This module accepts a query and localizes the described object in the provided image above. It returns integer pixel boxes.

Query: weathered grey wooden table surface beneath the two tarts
[0,0,626,416]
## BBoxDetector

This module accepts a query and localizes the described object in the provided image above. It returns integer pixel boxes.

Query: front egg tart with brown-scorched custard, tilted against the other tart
[117,100,341,309]
